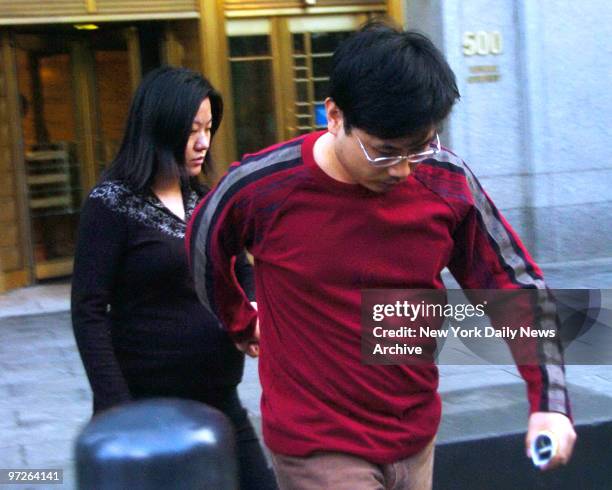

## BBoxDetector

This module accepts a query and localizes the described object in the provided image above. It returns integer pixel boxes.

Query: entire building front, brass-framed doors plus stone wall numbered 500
[0,0,612,291]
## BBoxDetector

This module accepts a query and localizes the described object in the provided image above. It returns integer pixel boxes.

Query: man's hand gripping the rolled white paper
[525,412,576,471]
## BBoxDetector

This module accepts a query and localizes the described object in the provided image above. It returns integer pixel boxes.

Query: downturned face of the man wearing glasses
[326,99,435,192]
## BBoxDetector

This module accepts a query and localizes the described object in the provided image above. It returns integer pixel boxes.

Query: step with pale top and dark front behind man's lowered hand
[434,384,612,490]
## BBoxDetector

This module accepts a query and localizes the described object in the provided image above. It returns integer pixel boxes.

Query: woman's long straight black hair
[102,66,223,192]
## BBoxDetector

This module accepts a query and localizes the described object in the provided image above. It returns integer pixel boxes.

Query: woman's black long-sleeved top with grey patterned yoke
[72,181,253,411]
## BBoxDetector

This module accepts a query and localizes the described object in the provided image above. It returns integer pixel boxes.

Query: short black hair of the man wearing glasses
[329,21,459,138]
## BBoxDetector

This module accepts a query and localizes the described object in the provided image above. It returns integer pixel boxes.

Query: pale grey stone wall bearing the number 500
[405,0,612,263]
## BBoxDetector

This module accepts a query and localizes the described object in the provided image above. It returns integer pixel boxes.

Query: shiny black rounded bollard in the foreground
[75,398,238,490]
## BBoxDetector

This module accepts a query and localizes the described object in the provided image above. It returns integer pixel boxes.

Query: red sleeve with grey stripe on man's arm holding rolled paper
[448,168,570,416]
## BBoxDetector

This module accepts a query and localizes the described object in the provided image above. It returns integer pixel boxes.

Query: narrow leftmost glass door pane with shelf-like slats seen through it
[16,35,82,279]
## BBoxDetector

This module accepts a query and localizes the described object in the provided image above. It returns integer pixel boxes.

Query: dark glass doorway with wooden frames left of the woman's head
[15,28,136,280]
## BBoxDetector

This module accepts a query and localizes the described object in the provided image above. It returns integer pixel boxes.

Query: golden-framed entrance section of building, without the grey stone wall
[0,0,403,291]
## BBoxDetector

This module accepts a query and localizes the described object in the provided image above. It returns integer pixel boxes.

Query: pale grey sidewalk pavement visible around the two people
[0,259,612,490]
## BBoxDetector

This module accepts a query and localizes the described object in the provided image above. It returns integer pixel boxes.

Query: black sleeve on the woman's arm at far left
[71,189,131,411]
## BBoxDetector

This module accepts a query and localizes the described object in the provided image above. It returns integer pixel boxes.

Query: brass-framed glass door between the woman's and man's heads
[226,14,367,156]
